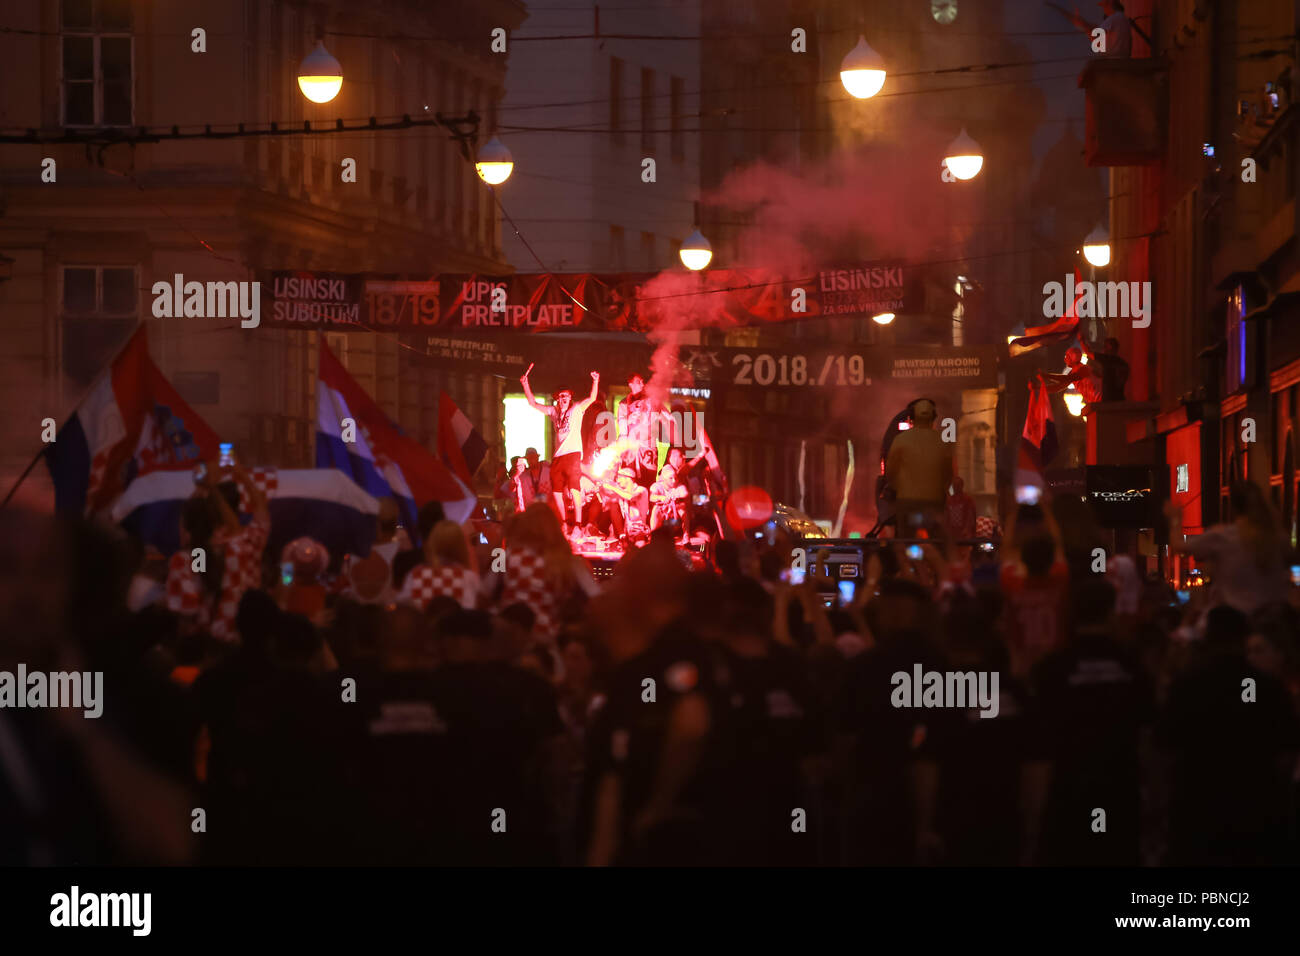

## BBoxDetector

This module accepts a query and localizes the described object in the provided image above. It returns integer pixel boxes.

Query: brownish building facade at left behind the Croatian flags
[0,0,524,509]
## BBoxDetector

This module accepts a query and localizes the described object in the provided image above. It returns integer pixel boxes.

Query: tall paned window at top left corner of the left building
[60,0,134,126]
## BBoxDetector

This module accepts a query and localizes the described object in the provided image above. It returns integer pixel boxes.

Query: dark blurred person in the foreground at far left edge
[0,509,196,866]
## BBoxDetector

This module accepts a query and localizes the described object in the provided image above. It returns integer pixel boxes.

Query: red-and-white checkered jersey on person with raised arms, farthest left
[166,519,269,641]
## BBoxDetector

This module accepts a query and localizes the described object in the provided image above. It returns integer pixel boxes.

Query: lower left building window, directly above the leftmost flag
[60,265,139,388]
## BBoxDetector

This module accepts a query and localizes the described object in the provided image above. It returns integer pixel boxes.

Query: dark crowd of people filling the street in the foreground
[0,447,1300,865]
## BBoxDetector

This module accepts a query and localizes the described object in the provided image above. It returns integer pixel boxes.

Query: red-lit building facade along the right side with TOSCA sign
[1089,0,1300,578]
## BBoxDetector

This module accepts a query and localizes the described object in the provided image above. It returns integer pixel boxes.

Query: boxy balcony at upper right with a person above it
[1079,57,1169,166]
